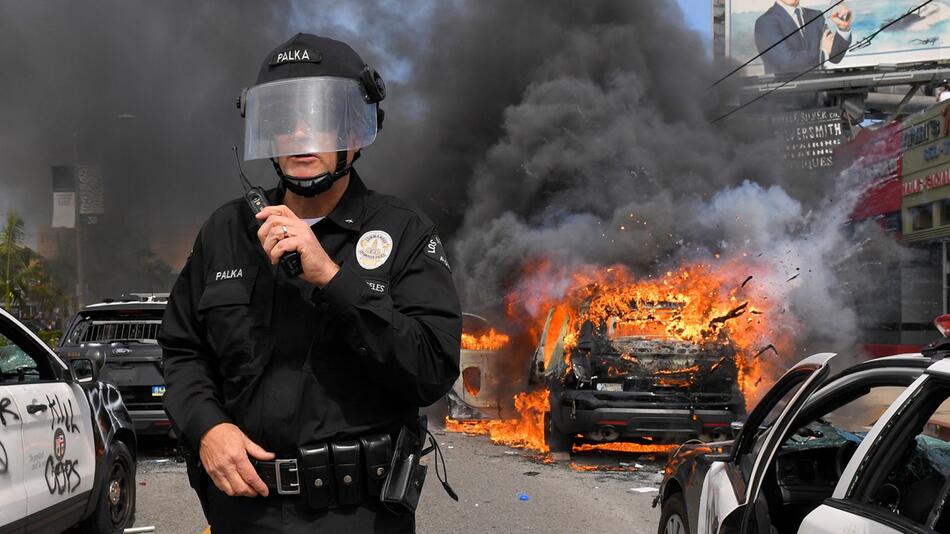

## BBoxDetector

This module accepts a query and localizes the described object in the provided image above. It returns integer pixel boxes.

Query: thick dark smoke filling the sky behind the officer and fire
[0,0,900,356]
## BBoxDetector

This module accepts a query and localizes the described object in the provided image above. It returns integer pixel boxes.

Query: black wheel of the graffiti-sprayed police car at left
[82,441,135,534]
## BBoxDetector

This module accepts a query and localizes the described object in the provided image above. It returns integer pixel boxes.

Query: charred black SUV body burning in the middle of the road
[532,300,745,451]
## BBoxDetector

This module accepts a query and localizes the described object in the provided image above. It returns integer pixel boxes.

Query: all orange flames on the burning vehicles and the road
[446,254,797,456]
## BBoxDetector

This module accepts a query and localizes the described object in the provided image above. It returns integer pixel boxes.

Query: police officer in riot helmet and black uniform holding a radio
[159,34,461,533]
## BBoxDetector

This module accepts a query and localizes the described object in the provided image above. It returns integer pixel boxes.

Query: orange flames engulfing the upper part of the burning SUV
[506,256,796,406]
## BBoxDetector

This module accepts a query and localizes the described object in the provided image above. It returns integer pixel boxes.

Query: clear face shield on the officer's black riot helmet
[244,77,377,160]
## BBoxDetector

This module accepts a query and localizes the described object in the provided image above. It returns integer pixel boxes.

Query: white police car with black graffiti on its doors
[0,309,135,534]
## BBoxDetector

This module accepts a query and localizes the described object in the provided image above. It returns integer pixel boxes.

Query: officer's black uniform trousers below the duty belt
[208,484,416,534]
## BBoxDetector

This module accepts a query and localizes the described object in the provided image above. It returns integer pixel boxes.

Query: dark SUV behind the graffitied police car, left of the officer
[56,294,171,436]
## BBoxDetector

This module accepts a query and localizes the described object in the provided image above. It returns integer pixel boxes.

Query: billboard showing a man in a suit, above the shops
[725,0,950,75]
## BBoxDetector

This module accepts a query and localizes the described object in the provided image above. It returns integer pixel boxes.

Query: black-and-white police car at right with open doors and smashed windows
[657,316,950,534]
